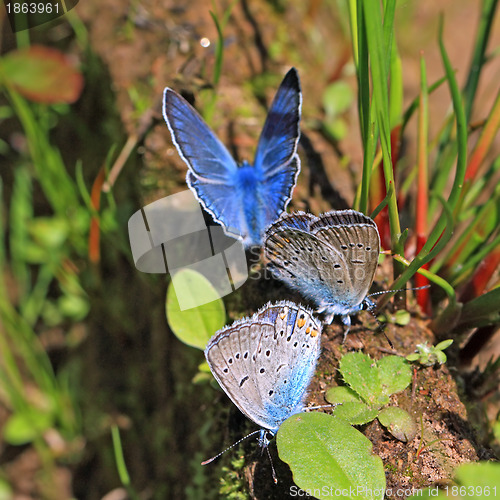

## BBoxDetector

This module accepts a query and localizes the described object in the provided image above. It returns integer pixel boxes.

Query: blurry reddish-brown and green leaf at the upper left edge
[0,45,83,104]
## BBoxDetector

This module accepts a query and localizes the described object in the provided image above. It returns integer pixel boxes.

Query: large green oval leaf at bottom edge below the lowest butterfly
[276,412,386,500]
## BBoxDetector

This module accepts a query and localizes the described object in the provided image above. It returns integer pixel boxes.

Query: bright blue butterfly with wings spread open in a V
[163,68,302,247]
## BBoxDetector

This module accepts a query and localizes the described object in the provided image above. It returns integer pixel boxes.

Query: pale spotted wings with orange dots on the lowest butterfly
[205,302,321,431]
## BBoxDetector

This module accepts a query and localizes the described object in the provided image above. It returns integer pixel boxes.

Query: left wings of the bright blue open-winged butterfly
[163,87,246,240]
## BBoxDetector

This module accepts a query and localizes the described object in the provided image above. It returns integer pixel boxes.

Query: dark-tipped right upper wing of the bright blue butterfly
[254,68,302,176]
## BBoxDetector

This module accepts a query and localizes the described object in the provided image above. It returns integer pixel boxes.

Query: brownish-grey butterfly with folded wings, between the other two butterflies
[265,210,380,333]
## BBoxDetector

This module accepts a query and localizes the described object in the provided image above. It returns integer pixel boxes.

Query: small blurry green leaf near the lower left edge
[3,408,53,446]
